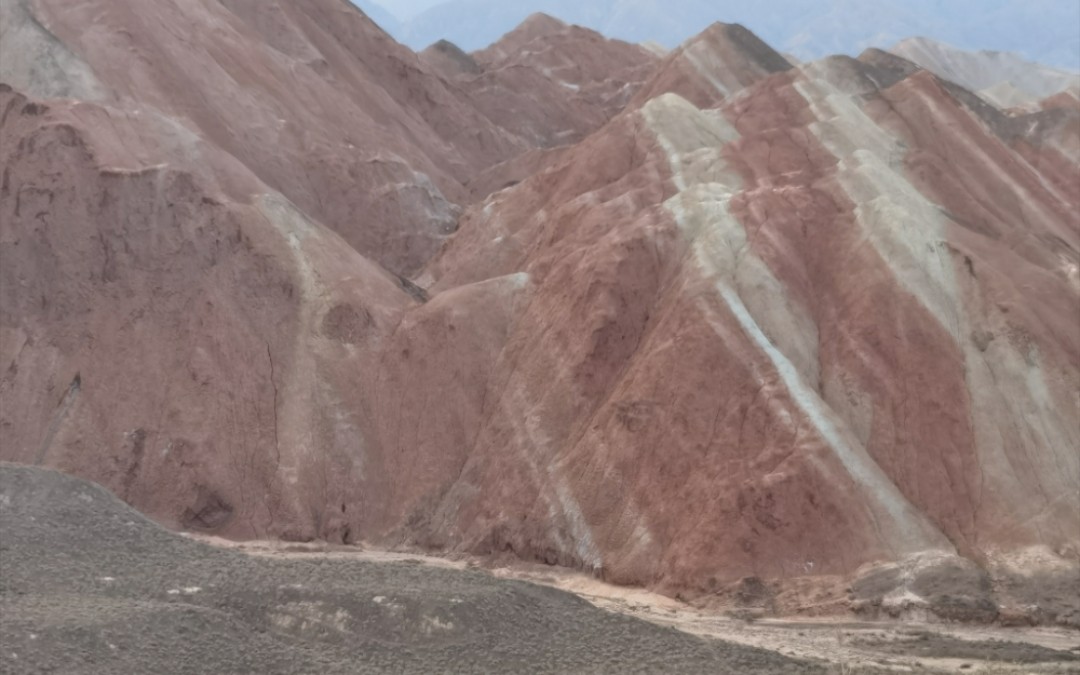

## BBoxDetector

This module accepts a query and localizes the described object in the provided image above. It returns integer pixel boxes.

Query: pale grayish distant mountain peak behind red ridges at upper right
[890,38,1080,107]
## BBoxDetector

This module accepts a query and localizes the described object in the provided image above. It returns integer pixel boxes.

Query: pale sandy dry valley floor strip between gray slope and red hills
[204,537,1080,674]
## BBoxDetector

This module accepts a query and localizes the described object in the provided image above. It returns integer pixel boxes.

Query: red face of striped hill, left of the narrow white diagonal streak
[416,83,945,592]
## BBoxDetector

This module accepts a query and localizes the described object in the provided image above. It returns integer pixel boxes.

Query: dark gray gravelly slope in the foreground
[0,463,818,674]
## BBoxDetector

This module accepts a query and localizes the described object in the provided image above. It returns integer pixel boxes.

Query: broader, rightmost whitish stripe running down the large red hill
[796,63,1080,533]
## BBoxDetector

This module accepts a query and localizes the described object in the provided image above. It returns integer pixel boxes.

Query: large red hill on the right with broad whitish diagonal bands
[420,38,1080,621]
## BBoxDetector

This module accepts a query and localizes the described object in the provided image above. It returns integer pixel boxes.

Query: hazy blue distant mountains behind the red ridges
[365,0,1080,70]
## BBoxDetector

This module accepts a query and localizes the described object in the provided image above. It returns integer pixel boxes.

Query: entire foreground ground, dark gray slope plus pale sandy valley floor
[6,464,1080,674]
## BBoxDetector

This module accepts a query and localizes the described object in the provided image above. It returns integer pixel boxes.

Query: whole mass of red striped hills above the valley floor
[0,0,1080,620]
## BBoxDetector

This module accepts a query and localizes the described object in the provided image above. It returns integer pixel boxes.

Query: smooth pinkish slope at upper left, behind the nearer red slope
[3,0,528,272]
